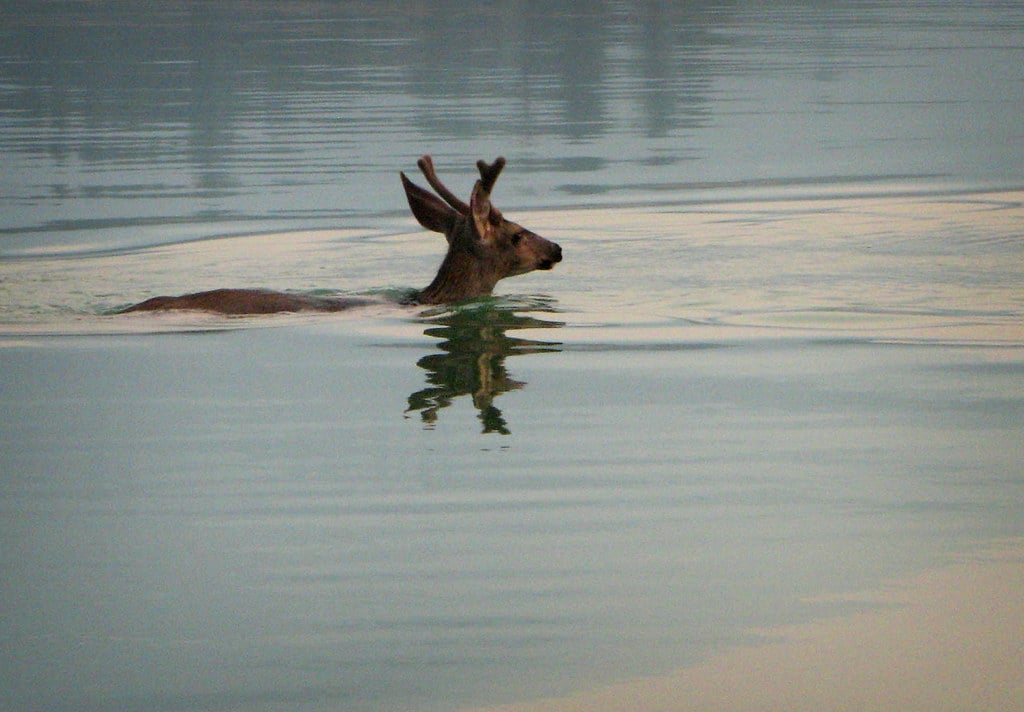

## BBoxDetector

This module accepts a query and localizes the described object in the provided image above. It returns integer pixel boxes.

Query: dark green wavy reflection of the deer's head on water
[406,299,563,434]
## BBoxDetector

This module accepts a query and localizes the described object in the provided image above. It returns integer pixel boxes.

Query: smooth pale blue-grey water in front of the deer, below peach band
[0,327,1024,710]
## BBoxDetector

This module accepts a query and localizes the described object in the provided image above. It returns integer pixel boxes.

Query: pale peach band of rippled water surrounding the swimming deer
[0,192,1024,344]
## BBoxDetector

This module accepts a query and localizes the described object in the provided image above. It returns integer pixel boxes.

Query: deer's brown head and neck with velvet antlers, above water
[401,156,562,304]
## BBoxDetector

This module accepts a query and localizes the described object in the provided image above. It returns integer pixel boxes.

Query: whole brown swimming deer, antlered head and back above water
[123,156,562,315]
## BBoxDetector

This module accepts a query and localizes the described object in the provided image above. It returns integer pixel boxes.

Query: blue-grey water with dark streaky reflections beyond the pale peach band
[0,0,1024,255]
